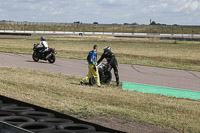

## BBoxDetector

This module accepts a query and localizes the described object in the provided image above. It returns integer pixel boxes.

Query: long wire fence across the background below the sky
[0,22,200,34]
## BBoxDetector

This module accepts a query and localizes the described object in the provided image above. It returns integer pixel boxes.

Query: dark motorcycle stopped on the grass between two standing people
[89,63,112,85]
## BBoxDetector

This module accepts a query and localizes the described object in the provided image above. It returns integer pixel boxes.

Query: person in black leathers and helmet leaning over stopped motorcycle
[97,46,119,86]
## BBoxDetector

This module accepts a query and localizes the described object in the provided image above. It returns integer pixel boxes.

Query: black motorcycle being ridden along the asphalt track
[32,44,56,63]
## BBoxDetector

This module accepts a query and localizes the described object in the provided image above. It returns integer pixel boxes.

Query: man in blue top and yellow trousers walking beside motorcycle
[80,45,103,88]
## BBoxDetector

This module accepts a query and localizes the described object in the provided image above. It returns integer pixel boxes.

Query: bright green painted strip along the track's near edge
[122,82,200,100]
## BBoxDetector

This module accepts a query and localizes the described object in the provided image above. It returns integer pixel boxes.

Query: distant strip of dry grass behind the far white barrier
[0,24,200,34]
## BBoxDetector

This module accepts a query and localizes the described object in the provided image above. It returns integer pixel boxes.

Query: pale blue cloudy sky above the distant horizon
[0,0,200,25]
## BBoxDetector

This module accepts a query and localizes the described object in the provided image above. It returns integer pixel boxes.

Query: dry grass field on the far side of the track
[0,35,200,71]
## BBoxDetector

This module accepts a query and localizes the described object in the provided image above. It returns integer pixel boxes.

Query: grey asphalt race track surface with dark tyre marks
[0,52,200,92]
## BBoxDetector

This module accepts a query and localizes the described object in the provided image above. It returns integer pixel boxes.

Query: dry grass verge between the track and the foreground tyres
[0,67,200,133]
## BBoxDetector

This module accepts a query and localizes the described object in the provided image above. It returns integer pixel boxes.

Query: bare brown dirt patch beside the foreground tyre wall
[81,117,180,133]
